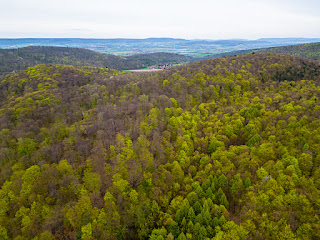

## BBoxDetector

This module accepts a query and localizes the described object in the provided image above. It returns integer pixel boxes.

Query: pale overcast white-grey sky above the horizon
[0,0,320,39]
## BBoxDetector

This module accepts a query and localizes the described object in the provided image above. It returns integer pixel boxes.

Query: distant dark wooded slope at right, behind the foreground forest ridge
[208,42,320,60]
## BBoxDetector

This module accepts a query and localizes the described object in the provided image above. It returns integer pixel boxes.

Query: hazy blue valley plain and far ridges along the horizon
[0,38,320,57]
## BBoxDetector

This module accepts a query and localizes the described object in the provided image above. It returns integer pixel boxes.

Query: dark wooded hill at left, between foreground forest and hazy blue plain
[0,47,196,75]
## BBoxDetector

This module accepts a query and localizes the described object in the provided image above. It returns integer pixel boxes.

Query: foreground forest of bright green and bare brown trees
[0,54,320,240]
